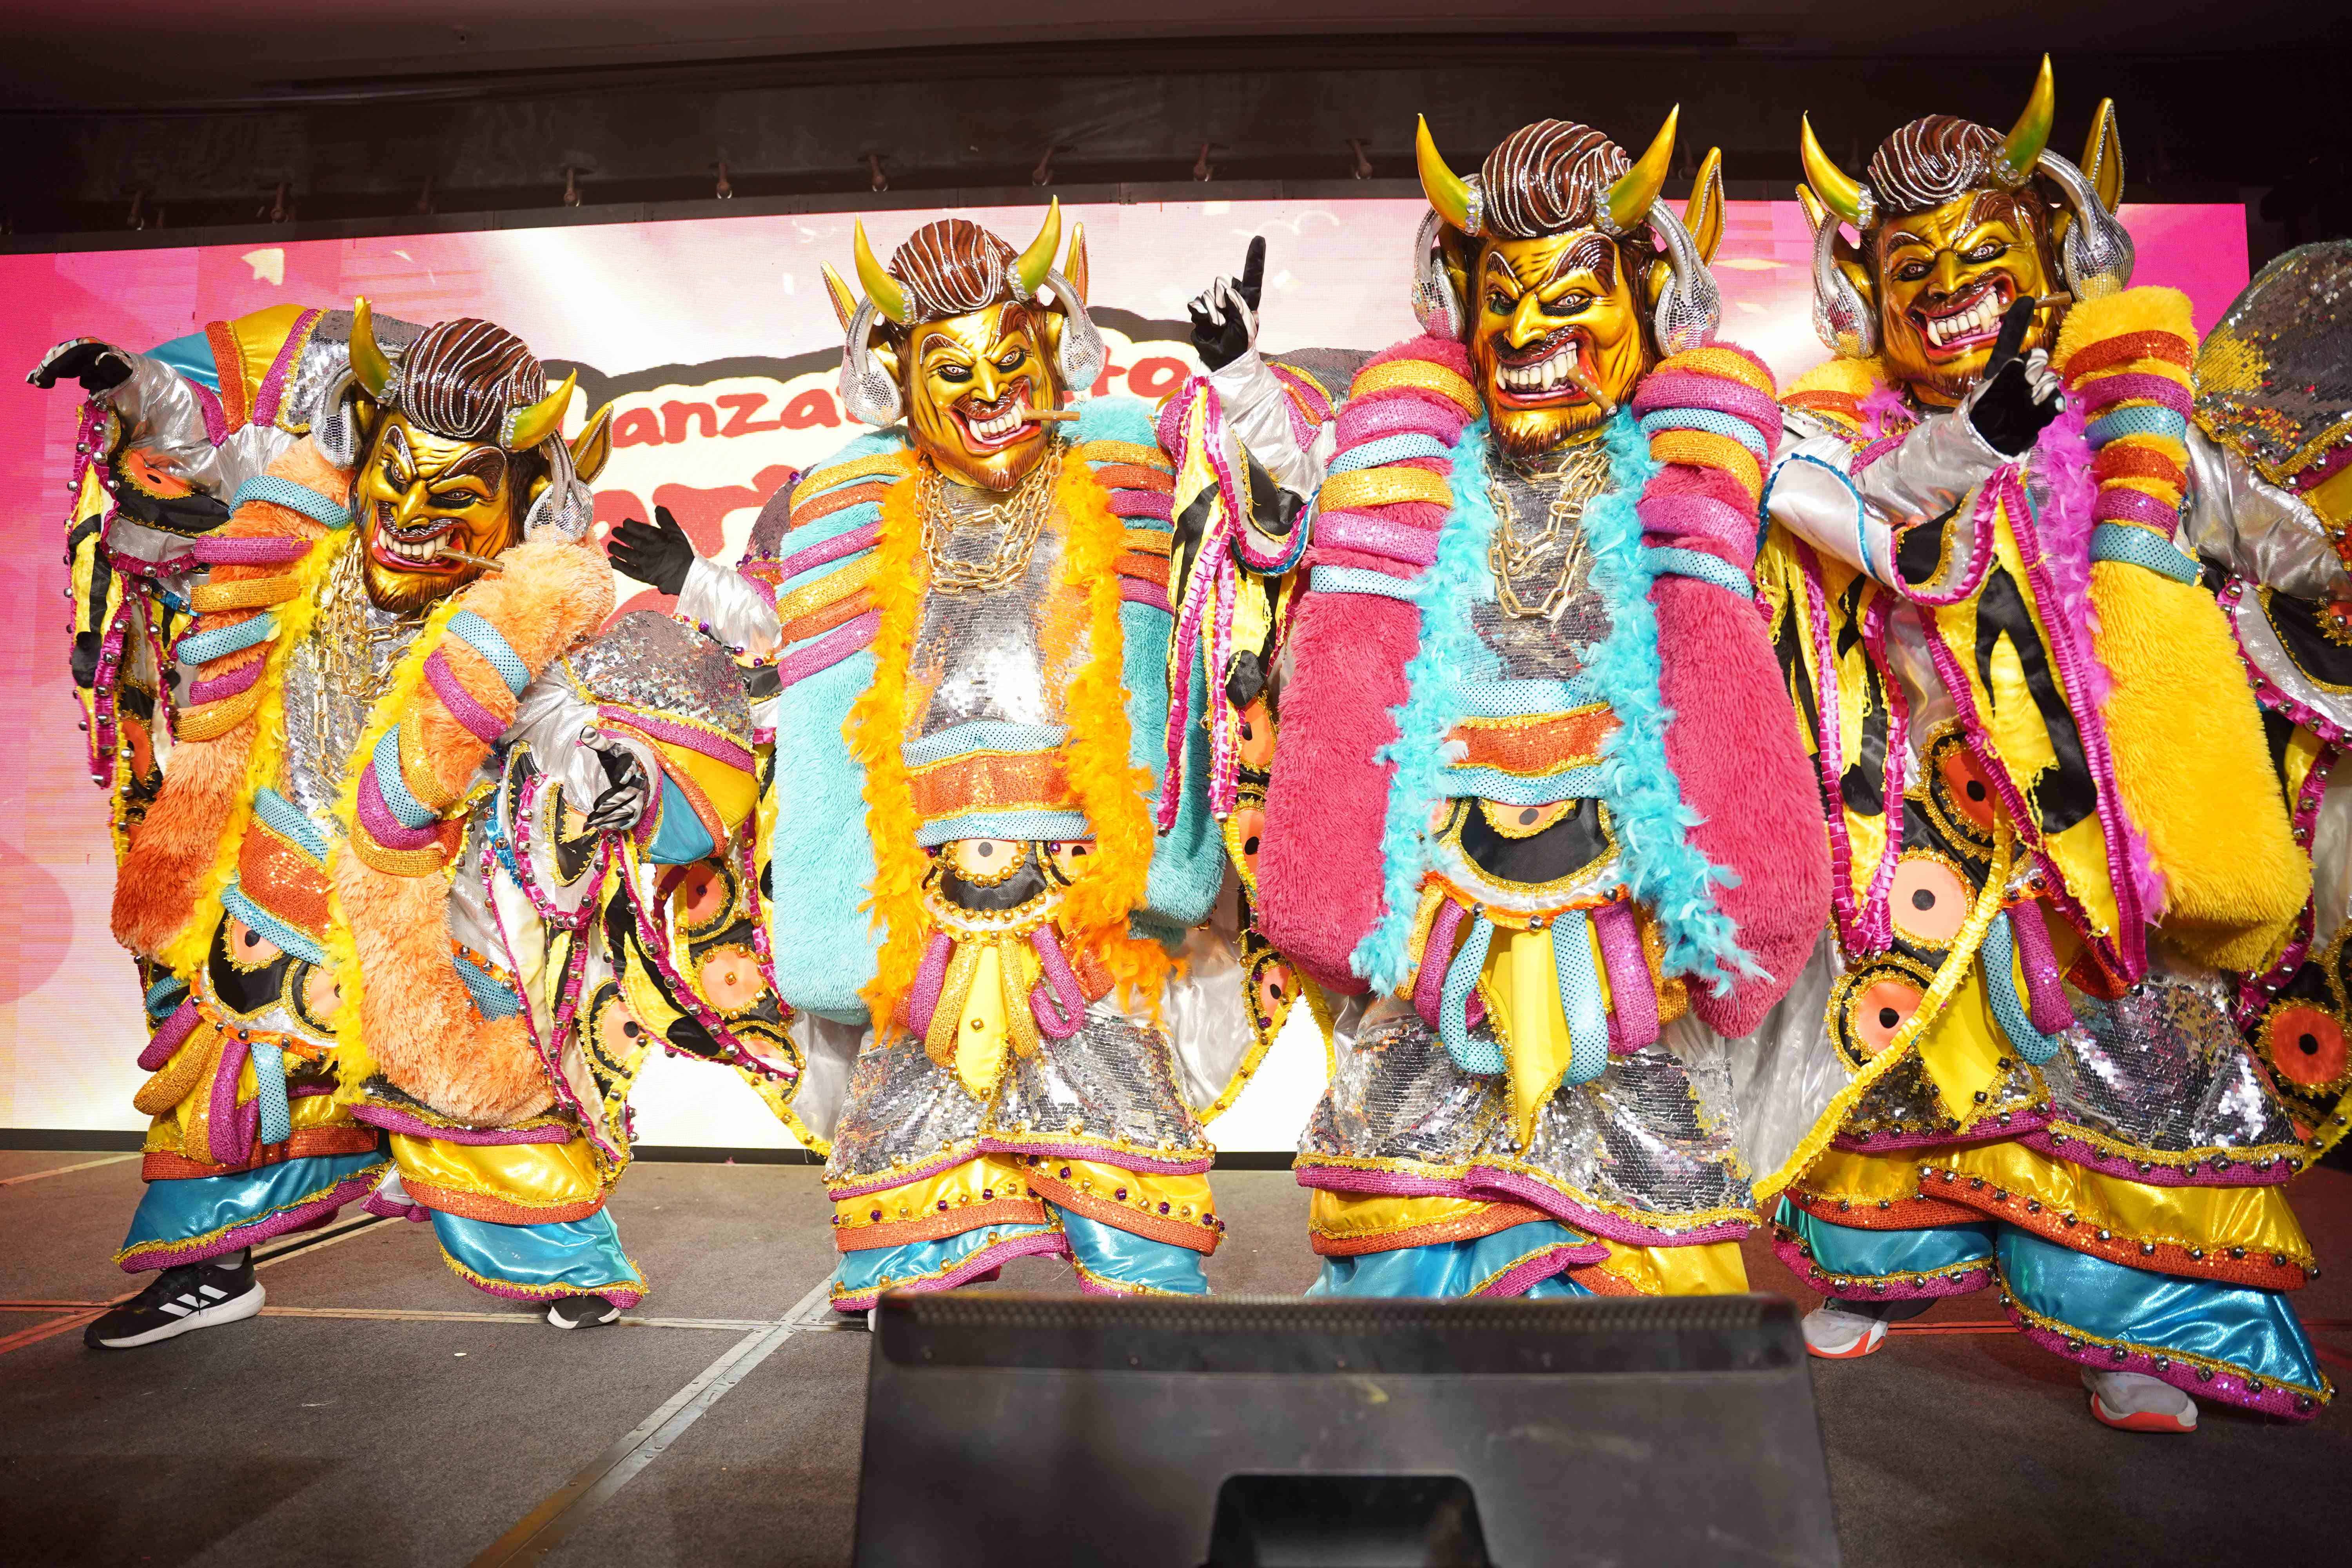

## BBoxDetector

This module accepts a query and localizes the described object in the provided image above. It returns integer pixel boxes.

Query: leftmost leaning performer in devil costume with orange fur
[45,301,753,1347]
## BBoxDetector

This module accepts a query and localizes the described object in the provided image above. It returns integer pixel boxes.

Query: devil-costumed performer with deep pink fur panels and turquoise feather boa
[1258,115,1828,1295]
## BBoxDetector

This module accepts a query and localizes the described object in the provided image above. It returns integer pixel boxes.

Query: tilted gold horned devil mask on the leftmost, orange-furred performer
[350,299,612,611]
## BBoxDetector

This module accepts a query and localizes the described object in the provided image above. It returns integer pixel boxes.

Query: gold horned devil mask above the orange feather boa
[826,202,1101,491]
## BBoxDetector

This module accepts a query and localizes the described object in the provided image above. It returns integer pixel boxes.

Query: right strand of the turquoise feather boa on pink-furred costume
[1571,409,1764,990]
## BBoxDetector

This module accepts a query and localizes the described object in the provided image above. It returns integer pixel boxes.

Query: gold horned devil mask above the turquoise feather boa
[1416,108,1724,458]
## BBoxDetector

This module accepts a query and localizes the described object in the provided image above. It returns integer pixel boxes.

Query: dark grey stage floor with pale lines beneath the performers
[0,1152,2352,1568]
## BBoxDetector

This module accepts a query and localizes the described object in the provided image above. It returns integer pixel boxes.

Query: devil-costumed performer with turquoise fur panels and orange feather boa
[616,207,1308,1312]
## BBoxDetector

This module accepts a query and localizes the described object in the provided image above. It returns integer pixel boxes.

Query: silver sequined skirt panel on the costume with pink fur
[1298,997,1755,1222]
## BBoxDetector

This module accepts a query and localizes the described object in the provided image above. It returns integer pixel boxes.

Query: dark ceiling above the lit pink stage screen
[0,0,2347,245]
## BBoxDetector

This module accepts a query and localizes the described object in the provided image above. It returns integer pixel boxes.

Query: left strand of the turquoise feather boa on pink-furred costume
[1348,418,1494,992]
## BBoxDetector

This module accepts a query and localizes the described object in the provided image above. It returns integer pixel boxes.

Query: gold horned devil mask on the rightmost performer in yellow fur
[1797,59,2129,407]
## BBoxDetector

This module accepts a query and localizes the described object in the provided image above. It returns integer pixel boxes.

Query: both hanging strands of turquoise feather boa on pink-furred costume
[1348,409,1762,992]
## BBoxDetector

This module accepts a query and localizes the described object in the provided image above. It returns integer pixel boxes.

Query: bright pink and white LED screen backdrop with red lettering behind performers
[0,200,2246,1147]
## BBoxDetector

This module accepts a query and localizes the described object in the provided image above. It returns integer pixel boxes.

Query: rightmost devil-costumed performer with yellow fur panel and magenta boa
[1757,64,2331,1432]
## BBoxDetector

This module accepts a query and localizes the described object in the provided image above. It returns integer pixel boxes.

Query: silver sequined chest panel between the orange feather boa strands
[906,484,1084,740]
